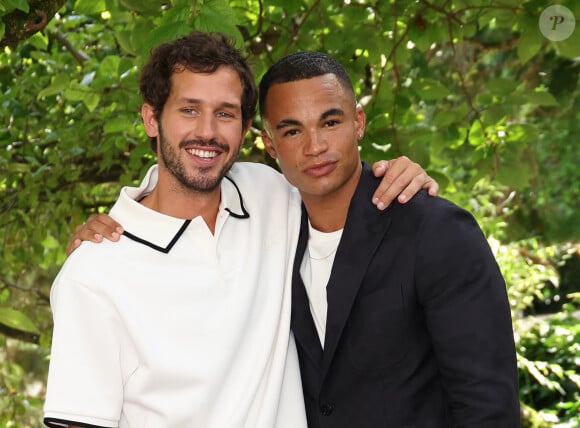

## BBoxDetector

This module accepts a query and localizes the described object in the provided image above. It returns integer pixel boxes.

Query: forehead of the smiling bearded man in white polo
[170,66,243,104]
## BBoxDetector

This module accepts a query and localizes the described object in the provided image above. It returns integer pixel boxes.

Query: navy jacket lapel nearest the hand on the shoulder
[320,164,390,379]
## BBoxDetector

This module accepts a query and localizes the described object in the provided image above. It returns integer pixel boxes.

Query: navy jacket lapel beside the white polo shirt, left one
[291,207,322,367]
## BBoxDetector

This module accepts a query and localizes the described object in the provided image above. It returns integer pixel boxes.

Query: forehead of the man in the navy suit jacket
[266,74,355,118]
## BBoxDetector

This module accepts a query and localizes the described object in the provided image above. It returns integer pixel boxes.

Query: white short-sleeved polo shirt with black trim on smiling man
[44,163,306,428]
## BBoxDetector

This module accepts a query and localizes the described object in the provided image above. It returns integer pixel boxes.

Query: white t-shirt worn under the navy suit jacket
[300,220,344,347]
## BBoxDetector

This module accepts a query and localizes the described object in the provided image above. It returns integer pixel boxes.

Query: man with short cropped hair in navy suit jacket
[259,52,519,428]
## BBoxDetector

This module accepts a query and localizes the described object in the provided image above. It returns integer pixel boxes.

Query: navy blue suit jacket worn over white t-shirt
[292,164,519,428]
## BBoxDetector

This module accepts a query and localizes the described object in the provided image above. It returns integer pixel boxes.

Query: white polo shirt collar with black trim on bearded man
[110,165,250,253]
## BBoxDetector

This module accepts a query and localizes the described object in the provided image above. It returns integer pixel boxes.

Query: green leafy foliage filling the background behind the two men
[0,0,580,427]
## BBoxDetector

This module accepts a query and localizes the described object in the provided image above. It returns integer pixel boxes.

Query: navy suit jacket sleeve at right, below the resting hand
[416,200,519,428]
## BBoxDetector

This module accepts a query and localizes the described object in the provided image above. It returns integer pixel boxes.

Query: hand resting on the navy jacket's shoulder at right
[373,156,439,210]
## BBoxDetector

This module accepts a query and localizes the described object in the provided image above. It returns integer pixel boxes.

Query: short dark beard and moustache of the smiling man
[159,123,241,193]
